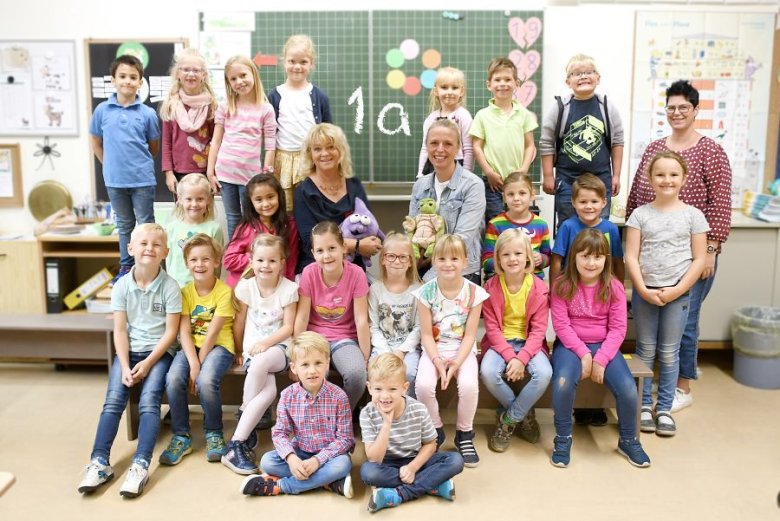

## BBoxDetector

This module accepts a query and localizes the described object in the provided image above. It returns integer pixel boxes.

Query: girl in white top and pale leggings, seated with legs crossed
[222,233,298,474]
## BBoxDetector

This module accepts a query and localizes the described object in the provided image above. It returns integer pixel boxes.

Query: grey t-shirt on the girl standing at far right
[626,204,710,287]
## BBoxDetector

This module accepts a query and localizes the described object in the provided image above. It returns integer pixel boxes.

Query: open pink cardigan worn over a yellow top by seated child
[482,275,549,365]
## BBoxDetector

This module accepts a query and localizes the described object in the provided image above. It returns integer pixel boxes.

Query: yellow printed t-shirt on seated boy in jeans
[181,279,236,354]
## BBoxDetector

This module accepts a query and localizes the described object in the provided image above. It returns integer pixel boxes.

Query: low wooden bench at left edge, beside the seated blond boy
[0,313,114,364]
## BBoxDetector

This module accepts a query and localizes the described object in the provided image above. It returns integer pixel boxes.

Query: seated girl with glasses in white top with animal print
[368,232,420,398]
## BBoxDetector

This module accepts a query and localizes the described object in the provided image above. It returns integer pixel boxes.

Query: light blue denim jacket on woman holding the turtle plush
[409,164,485,282]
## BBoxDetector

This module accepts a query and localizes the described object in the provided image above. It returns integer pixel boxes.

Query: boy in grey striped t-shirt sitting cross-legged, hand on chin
[360,353,463,512]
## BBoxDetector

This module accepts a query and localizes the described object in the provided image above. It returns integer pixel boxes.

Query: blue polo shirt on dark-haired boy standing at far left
[89,94,160,188]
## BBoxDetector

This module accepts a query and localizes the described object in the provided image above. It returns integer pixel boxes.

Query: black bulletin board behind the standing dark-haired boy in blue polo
[84,38,188,201]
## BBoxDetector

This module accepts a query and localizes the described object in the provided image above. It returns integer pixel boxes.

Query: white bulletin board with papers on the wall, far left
[0,40,79,136]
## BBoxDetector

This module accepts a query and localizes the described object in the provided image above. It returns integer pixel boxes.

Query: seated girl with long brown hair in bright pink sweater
[550,228,650,467]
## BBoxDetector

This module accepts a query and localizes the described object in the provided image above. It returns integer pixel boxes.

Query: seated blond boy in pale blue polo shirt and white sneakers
[79,223,181,498]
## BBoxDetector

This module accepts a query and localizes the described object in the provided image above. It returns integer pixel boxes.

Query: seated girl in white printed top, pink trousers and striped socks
[412,235,488,467]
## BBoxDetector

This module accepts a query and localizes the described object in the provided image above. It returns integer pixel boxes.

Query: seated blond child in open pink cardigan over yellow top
[479,228,552,452]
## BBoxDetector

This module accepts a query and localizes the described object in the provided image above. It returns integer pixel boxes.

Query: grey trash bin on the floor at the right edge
[731,306,780,389]
